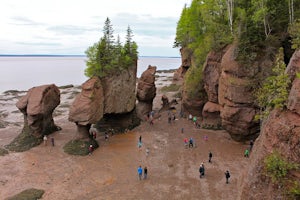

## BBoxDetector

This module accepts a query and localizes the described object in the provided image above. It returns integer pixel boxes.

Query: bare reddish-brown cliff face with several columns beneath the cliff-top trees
[182,45,273,141]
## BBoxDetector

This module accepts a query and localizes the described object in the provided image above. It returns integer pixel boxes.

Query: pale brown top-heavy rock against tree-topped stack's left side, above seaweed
[69,77,104,138]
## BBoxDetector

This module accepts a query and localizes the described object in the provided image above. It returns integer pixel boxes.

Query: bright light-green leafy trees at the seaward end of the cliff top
[174,0,233,66]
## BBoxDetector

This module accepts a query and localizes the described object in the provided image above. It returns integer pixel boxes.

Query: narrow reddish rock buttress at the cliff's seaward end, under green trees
[173,48,192,81]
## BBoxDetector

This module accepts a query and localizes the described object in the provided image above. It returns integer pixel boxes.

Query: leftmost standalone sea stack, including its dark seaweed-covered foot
[7,84,60,151]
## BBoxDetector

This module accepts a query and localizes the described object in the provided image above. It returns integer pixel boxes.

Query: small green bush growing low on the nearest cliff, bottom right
[264,151,296,183]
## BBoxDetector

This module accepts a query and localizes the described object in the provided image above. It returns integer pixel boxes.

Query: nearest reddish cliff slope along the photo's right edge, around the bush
[239,48,300,200]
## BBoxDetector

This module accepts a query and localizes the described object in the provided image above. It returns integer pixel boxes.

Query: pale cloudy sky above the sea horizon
[0,0,191,57]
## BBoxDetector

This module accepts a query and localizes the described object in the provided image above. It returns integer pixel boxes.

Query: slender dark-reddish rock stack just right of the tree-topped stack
[136,65,156,119]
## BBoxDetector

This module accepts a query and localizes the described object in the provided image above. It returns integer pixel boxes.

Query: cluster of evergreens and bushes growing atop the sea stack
[85,18,138,77]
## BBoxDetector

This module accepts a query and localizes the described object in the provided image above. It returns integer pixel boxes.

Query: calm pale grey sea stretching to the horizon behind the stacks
[0,56,181,93]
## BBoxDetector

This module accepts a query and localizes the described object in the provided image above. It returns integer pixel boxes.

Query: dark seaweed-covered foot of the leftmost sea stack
[5,126,42,152]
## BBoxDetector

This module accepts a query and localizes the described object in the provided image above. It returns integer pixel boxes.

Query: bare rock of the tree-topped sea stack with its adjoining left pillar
[69,66,139,138]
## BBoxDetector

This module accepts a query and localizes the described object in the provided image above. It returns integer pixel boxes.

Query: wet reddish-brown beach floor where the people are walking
[0,74,248,200]
